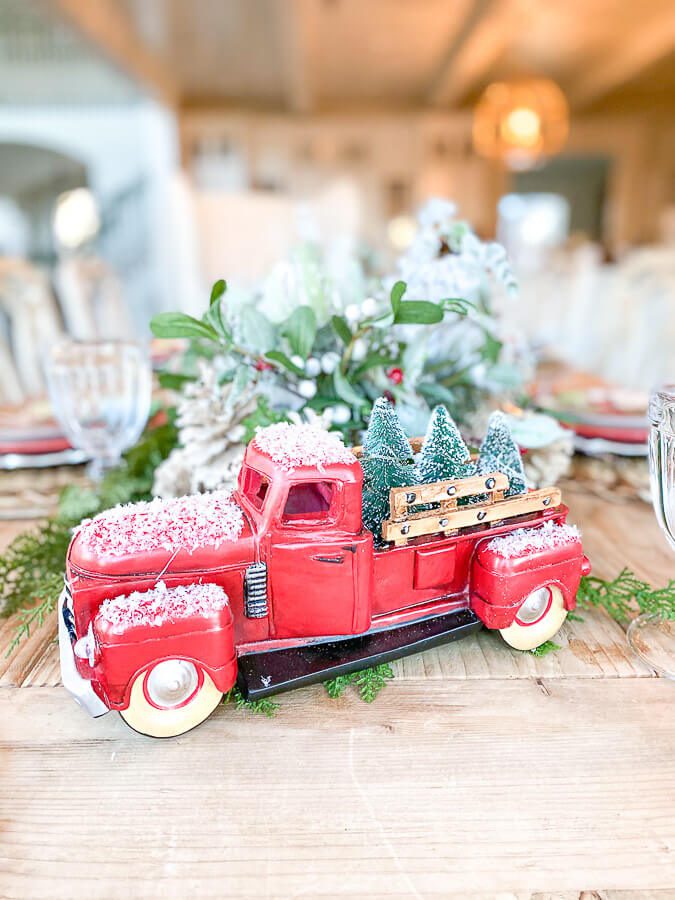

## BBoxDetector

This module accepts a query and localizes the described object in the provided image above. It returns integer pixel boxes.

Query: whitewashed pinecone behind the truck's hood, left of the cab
[153,361,256,497]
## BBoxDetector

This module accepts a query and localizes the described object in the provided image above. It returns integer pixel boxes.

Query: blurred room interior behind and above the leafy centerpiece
[0,0,675,404]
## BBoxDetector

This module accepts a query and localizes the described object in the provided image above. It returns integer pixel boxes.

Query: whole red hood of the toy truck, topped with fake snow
[69,491,251,574]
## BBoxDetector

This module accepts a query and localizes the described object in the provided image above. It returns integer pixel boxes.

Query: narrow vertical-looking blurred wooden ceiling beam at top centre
[279,0,319,113]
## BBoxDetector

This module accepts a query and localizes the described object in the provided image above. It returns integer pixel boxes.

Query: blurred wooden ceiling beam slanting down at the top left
[39,0,179,106]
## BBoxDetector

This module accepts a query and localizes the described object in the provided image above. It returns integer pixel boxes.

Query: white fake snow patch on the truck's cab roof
[253,422,356,472]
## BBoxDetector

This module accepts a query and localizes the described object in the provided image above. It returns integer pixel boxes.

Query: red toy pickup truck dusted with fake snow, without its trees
[59,424,590,737]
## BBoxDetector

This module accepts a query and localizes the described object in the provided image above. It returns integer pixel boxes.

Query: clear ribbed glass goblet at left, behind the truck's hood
[45,340,152,481]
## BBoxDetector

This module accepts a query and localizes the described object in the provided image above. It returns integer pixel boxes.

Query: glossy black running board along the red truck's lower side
[237,609,482,700]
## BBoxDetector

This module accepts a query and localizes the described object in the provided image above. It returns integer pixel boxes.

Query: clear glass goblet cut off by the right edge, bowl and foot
[627,385,675,679]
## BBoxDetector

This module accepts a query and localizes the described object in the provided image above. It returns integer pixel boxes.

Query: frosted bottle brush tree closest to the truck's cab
[361,397,415,540]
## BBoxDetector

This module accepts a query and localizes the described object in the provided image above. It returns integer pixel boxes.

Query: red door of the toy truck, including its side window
[268,478,357,638]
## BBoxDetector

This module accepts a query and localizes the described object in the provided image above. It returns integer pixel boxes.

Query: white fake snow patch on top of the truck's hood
[78,491,244,557]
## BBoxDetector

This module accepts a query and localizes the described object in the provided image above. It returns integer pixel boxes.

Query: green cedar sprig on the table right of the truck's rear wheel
[577,569,675,622]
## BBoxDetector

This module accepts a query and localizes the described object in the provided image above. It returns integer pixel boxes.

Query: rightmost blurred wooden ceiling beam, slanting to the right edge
[567,15,675,109]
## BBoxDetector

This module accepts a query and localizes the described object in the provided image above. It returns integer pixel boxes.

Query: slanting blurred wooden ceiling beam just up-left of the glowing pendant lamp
[425,0,516,107]
